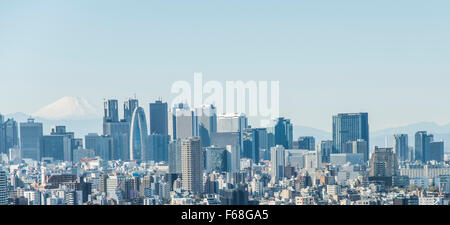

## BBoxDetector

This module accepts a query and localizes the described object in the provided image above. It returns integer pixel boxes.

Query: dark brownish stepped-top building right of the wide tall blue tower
[370,146,398,178]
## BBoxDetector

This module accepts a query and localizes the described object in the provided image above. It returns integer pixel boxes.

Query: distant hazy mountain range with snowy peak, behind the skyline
[5,97,450,152]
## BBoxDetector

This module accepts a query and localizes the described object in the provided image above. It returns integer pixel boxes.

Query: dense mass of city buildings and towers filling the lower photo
[0,102,450,205]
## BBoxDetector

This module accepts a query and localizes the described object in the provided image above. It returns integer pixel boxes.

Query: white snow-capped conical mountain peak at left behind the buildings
[31,97,101,120]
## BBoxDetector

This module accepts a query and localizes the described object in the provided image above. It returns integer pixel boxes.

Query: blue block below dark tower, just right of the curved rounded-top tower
[146,134,170,162]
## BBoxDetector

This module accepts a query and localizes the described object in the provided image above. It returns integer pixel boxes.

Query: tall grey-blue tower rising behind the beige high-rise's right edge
[195,105,217,147]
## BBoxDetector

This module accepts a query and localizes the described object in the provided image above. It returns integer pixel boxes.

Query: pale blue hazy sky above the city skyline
[0,0,450,130]
